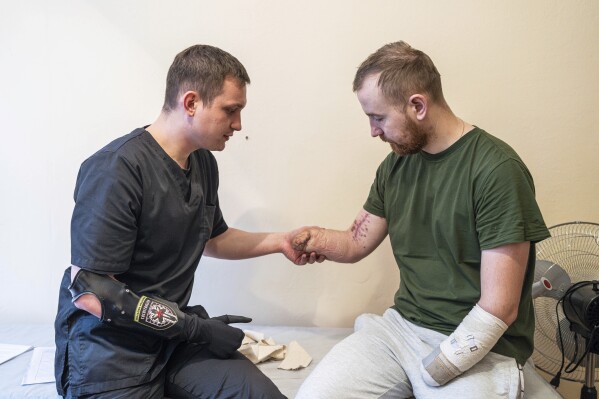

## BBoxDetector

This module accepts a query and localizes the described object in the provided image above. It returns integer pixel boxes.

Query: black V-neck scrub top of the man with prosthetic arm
[55,128,227,395]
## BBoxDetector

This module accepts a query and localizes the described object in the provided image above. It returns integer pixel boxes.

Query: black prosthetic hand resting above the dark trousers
[184,305,252,359]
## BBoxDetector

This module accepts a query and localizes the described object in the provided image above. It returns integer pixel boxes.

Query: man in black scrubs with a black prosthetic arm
[55,45,322,399]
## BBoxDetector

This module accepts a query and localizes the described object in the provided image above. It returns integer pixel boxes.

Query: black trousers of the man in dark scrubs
[66,344,285,399]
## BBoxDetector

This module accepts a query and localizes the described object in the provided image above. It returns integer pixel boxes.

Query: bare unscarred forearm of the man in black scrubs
[204,228,287,260]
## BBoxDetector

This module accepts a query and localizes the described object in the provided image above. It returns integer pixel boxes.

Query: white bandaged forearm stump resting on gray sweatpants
[420,305,508,386]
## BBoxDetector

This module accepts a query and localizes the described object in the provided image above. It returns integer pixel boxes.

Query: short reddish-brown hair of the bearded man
[353,41,445,105]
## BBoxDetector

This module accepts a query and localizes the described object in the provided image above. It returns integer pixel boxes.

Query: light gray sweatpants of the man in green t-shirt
[296,309,556,399]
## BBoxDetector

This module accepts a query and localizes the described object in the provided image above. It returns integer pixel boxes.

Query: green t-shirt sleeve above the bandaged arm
[475,159,549,249]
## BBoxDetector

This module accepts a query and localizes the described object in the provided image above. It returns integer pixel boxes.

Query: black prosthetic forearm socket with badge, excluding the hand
[69,269,187,339]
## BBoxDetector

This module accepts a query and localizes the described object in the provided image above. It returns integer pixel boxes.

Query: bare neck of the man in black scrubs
[146,112,193,169]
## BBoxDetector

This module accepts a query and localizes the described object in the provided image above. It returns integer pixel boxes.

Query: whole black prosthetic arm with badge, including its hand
[69,269,251,358]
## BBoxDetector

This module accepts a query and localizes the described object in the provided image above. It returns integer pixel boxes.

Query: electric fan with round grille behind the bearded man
[532,222,599,399]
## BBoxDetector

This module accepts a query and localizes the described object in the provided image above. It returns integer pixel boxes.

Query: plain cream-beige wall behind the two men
[0,0,599,396]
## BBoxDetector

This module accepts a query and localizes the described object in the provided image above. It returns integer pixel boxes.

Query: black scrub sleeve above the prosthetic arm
[71,151,142,274]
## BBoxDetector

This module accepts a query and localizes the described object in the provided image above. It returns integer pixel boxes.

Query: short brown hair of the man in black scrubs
[162,44,250,111]
